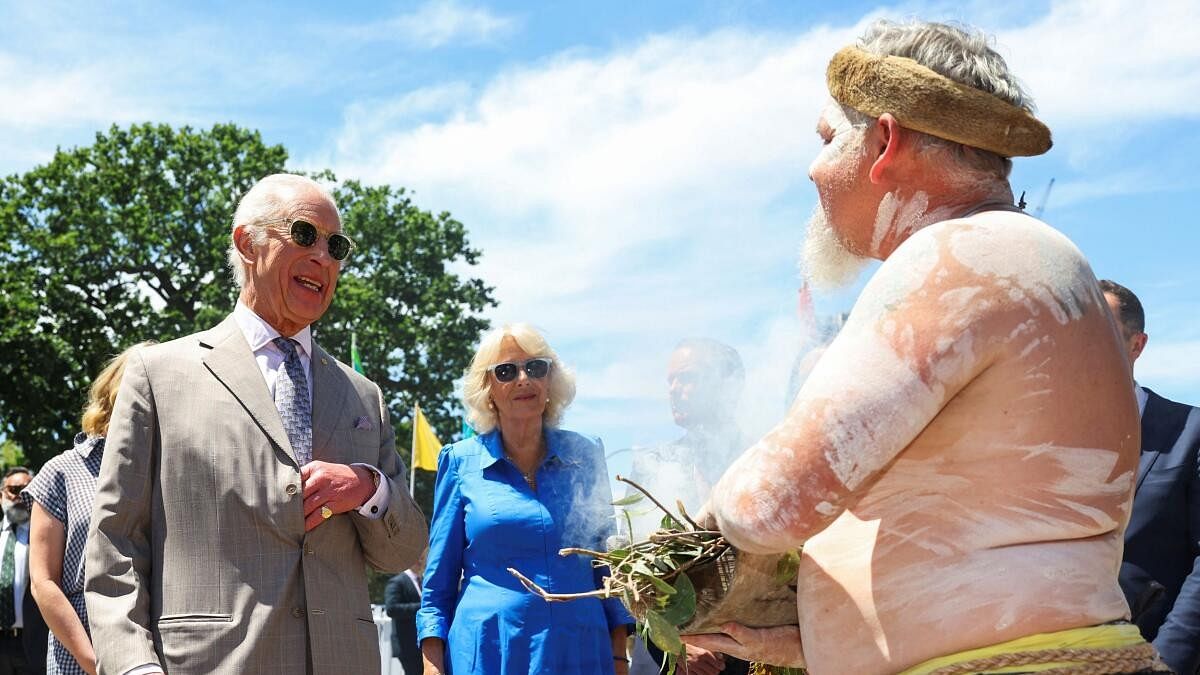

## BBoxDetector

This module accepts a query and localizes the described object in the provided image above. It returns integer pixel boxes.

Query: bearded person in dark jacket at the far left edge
[0,466,47,675]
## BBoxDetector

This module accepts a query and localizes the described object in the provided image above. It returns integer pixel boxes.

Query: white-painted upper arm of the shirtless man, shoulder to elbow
[709,223,998,554]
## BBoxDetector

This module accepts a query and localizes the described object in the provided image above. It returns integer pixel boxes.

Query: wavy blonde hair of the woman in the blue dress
[462,323,575,434]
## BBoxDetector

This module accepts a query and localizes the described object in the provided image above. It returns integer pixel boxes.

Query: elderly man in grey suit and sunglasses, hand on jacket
[85,174,426,675]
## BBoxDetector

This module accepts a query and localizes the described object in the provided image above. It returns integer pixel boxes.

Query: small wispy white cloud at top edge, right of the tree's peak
[340,0,517,49]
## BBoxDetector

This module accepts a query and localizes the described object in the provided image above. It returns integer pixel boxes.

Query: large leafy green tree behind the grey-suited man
[0,124,493,473]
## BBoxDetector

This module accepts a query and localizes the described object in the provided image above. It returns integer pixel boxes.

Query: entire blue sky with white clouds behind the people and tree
[0,0,1200,471]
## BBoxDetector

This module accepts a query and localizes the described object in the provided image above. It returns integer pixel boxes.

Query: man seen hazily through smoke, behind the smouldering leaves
[625,338,750,675]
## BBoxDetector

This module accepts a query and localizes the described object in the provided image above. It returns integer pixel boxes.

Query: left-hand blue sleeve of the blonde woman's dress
[416,446,467,644]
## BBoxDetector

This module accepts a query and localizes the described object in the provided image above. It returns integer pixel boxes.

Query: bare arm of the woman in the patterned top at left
[29,502,96,675]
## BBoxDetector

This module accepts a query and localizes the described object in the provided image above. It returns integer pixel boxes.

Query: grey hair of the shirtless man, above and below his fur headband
[842,19,1034,179]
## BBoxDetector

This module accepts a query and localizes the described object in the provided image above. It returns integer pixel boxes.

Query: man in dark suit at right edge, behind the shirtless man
[1100,280,1200,675]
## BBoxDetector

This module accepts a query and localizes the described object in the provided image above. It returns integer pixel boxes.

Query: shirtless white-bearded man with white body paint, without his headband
[685,22,1153,675]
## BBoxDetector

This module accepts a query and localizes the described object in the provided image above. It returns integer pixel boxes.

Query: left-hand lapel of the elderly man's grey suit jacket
[200,316,300,467]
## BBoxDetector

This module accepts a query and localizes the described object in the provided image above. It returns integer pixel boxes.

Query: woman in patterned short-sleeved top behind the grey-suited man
[22,342,149,675]
